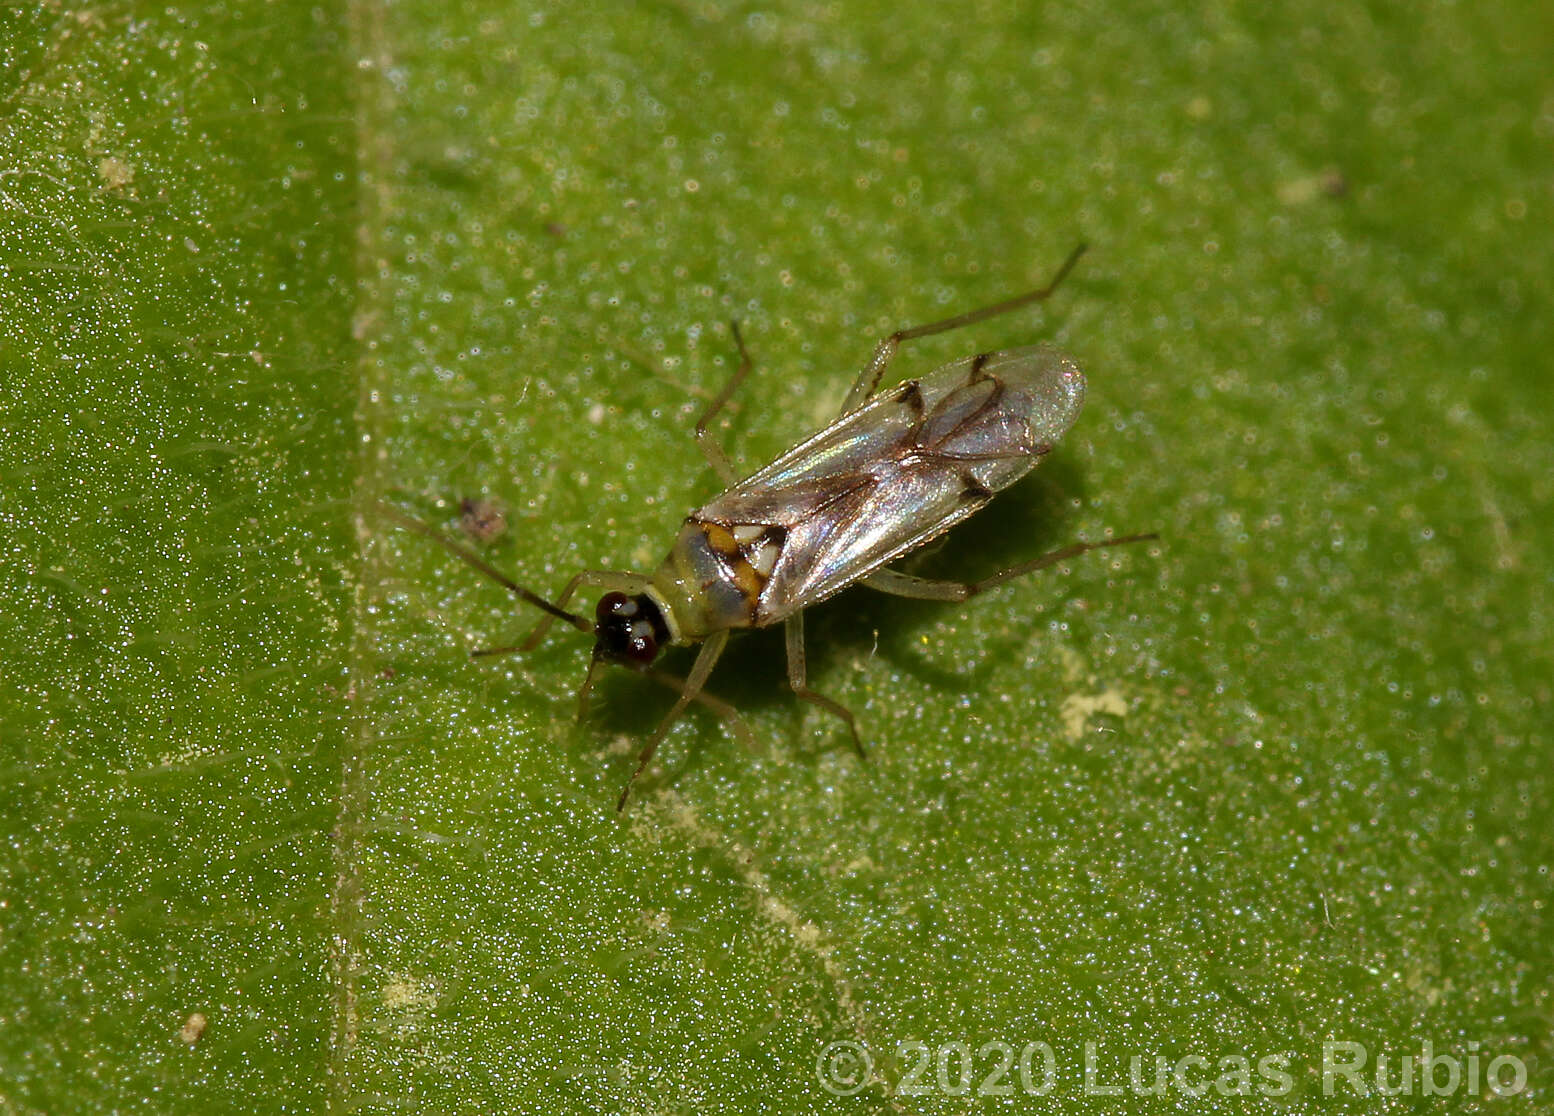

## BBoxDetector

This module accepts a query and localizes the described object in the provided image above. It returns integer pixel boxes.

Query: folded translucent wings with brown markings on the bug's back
[692,345,1085,623]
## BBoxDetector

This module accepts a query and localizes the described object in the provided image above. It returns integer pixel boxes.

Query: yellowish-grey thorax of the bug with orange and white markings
[653,519,786,642]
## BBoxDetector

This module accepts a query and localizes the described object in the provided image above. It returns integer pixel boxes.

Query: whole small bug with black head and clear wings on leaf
[384,244,1156,810]
